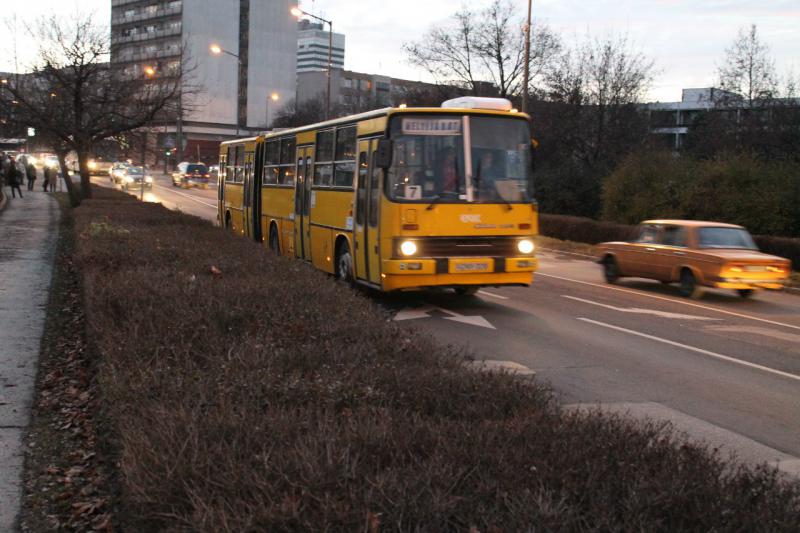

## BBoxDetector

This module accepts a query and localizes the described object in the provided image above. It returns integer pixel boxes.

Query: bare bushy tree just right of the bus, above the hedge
[531,36,654,216]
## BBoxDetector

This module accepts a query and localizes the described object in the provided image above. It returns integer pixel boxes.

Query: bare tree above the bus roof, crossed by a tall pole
[403,0,561,98]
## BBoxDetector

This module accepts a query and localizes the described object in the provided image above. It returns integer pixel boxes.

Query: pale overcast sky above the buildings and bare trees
[0,0,800,101]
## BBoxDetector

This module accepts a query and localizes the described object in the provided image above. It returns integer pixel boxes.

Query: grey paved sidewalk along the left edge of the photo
[0,190,60,532]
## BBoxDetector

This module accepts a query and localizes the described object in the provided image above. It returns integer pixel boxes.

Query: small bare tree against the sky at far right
[719,24,778,107]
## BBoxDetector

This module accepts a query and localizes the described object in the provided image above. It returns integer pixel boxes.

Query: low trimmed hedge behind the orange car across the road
[539,214,800,270]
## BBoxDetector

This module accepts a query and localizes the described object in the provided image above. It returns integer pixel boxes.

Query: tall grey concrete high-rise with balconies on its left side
[111,0,298,164]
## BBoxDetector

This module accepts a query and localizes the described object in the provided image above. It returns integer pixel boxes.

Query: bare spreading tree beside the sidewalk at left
[0,14,187,204]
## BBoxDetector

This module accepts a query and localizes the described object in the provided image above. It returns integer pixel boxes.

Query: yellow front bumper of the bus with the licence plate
[382,257,539,291]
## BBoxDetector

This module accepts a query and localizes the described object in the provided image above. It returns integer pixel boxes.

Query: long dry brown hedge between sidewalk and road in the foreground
[76,191,800,531]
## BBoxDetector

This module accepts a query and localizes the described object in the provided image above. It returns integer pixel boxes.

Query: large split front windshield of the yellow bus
[386,115,532,203]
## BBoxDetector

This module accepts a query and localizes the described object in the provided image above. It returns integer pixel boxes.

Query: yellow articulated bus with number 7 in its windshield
[218,97,538,294]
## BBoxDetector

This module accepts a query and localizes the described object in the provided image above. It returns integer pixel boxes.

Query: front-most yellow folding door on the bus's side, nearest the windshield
[354,139,381,285]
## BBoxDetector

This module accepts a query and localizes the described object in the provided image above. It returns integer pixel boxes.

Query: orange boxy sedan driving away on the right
[598,220,791,298]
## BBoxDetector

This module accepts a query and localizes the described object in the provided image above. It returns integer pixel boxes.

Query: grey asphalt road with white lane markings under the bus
[98,177,800,475]
